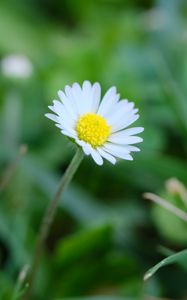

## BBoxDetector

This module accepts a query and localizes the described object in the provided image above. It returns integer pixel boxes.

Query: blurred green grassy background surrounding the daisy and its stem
[0,0,187,300]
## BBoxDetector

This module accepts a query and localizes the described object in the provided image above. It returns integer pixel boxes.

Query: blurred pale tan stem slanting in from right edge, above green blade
[143,193,187,222]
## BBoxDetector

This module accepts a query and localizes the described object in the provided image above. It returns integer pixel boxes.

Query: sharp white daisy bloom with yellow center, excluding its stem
[46,81,144,165]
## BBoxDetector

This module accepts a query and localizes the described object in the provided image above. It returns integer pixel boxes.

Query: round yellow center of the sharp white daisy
[76,113,111,147]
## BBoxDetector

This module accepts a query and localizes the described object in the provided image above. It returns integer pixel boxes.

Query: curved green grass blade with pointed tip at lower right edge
[144,249,187,280]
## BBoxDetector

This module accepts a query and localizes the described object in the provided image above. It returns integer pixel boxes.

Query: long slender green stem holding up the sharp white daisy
[23,149,83,300]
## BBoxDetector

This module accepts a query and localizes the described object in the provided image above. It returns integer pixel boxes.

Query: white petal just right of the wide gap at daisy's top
[97,87,119,116]
